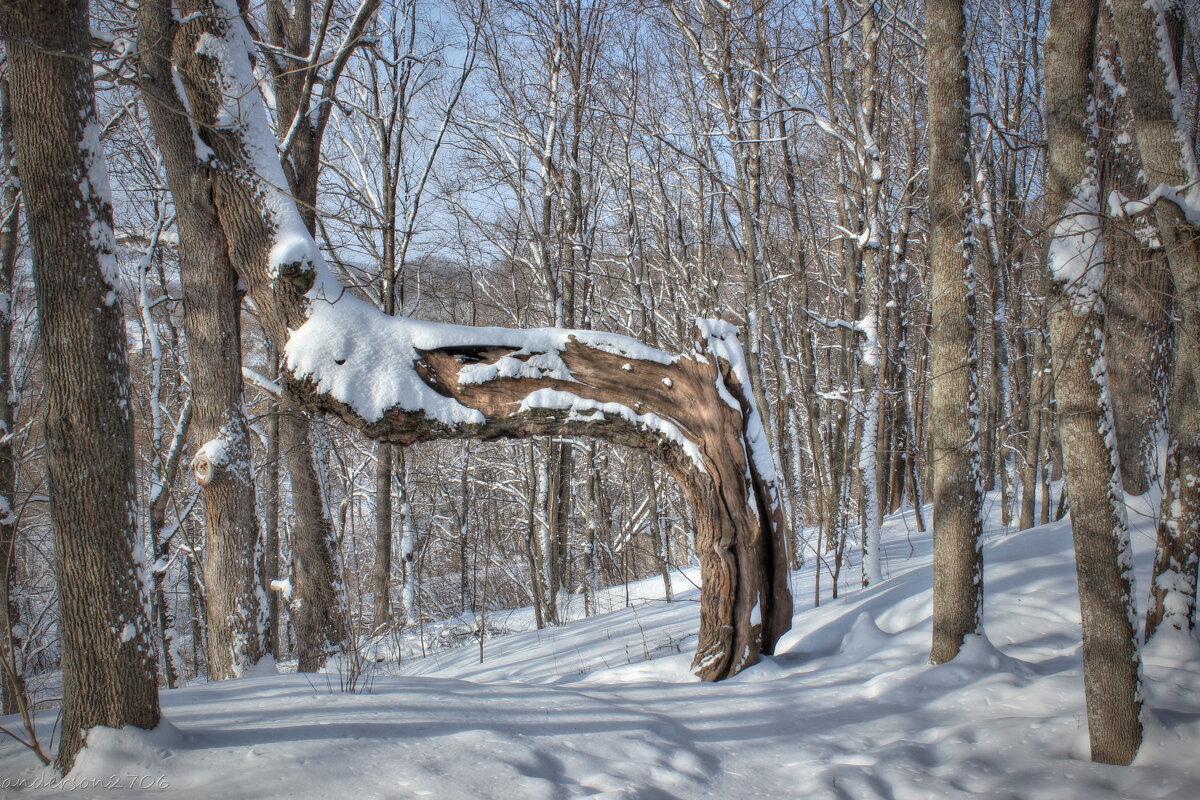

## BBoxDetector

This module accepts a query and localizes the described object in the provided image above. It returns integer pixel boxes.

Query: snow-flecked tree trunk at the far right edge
[1112,0,1200,638]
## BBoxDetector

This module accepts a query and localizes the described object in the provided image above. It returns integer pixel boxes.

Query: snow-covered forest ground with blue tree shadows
[0,496,1200,800]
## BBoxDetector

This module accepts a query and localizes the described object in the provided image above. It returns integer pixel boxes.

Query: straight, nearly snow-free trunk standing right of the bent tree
[925,0,983,663]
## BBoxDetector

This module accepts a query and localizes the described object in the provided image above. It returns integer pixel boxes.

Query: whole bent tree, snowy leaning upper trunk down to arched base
[164,0,792,680]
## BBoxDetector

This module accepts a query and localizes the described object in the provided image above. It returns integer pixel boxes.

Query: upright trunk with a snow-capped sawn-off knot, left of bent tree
[138,0,265,680]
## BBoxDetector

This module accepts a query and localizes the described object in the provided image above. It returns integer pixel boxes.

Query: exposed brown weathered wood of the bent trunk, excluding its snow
[288,329,792,680]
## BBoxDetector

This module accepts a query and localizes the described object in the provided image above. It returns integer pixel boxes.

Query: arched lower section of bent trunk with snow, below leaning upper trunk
[284,316,792,680]
